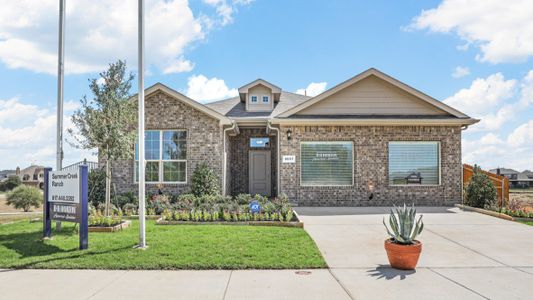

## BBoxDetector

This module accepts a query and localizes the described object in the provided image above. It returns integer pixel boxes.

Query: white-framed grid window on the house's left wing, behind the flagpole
[135,130,187,183]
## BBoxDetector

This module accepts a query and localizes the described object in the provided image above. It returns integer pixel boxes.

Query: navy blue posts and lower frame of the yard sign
[43,165,89,250]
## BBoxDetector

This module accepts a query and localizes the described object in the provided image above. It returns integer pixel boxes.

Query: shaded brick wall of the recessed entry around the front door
[229,128,277,196]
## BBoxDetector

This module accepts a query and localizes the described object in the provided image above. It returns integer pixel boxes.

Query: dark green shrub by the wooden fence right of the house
[464,166,496,208]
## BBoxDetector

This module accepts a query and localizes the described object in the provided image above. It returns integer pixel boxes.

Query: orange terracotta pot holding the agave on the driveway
[385,239,422,270]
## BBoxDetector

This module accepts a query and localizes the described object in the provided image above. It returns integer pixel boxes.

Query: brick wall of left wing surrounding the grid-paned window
[109,92,223,194]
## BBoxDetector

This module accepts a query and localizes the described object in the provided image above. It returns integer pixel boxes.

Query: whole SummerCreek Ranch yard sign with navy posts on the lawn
[43,165,89,250]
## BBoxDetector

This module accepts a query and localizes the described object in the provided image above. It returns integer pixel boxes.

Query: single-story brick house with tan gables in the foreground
[108,69,479,206]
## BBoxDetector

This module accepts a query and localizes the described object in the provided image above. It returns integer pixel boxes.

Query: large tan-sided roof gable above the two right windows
[278,68,469,118]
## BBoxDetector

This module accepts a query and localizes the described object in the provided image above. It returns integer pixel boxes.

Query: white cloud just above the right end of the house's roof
[444,73,516,117]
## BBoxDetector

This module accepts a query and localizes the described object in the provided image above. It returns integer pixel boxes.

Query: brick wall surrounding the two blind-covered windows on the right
[280,126,462,206]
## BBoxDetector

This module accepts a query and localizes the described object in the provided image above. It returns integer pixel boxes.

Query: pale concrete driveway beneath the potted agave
[297,207,533,299]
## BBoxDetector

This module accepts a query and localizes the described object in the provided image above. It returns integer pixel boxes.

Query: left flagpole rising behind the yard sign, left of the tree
[56,0,65,230]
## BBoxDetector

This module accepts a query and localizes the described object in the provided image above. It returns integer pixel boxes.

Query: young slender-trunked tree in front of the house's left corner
[68,60,137,215]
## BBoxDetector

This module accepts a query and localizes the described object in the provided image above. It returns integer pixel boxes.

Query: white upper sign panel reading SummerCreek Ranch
[48,170,80,204]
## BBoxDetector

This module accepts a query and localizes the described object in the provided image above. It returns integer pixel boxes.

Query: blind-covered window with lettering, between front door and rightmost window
[300,141,353,186]
